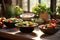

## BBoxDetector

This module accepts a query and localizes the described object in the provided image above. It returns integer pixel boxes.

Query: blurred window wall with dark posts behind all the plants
[0,0,60,17]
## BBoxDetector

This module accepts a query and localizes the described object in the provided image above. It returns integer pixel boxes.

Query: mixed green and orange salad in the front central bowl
[16,21,38,27]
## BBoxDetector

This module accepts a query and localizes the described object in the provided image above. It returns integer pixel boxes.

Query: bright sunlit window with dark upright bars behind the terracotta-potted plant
[22,0,50,12]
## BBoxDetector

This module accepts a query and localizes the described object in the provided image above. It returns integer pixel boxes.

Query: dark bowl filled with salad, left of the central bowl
[3,18,19,28]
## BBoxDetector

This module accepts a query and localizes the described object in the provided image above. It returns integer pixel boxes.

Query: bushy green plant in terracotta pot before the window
[32,4,52,20]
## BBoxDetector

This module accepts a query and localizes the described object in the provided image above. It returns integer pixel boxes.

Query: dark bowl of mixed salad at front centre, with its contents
[15,21,38,33]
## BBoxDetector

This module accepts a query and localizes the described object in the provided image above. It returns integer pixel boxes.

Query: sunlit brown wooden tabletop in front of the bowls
[0,28,60,40]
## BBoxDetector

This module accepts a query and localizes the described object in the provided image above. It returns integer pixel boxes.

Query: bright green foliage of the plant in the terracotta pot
[32,4,52,15]
